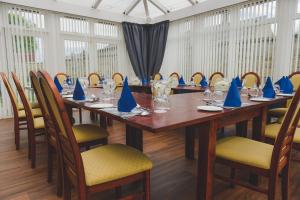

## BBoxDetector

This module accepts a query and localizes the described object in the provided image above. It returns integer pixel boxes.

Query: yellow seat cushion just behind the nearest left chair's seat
[72,124,108,143]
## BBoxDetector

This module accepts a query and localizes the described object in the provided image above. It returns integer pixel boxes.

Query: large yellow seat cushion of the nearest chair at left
[81,144,153,186]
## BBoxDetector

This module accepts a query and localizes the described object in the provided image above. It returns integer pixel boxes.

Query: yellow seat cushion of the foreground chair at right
[216,136,273,169]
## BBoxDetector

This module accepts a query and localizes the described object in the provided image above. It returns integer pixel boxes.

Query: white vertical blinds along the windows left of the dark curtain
[0,3,133,118]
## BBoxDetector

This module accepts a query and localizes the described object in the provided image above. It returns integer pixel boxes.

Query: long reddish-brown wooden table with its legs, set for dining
[64,88,287,200]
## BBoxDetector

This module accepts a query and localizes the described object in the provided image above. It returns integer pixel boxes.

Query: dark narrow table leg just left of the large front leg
[185,126,195,160]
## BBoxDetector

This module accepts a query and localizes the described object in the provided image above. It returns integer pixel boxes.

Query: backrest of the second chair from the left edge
[11,72,34,129]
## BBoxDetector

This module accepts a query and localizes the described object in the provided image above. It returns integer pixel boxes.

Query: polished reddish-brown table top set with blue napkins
[64,88,288,132]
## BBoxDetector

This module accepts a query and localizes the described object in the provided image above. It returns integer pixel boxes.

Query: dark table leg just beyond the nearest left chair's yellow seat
[126,125,143,151]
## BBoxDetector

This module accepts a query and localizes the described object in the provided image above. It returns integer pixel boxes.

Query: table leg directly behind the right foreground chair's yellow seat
[249,107,267,185]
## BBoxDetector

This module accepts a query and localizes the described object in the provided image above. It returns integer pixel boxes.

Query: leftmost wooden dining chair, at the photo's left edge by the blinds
[0,72,42,150]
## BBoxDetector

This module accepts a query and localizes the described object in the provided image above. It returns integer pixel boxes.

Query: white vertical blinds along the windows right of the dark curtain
[162,0,277,82]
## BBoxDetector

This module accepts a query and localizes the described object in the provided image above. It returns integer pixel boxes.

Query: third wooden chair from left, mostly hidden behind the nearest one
[30,71,108,196]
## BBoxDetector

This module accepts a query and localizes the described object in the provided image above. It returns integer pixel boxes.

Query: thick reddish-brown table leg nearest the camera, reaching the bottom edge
[196,121,217,200]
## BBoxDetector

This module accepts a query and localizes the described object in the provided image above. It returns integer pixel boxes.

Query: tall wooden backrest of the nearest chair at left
[38,71,86,190]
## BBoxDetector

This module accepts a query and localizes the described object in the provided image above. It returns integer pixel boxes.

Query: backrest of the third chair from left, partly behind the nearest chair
[30,71,56,141]
